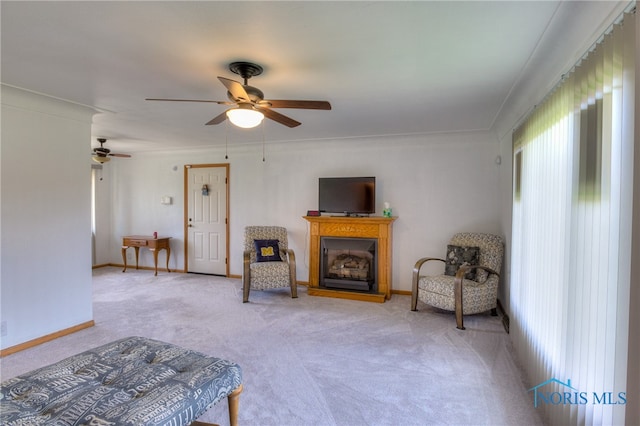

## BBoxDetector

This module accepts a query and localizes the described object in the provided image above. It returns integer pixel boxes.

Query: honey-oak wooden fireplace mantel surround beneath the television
[304,216,396,303]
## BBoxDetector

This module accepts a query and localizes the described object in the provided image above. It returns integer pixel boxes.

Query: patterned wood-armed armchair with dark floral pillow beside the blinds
[411,232,504,330]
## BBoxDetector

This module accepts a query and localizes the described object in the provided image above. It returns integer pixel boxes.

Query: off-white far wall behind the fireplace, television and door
[105,132,501,291]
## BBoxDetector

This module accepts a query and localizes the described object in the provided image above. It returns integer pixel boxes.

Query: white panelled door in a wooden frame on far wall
[185,165,228,275]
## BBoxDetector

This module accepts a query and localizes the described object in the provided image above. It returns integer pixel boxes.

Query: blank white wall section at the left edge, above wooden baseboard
[0,85,94,349]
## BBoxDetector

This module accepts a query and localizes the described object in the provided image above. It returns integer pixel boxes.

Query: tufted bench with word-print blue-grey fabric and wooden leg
[0,337,242,426]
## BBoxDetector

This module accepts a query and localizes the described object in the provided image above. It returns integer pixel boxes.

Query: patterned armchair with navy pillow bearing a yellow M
[242,226,298,303]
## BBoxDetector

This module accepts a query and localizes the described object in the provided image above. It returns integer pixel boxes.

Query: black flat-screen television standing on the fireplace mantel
[318,177,376,216]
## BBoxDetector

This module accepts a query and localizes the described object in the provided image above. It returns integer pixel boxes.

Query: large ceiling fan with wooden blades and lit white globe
[146,62,331,129]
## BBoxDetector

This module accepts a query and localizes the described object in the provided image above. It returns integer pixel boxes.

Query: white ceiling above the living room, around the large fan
[1,1,624,152]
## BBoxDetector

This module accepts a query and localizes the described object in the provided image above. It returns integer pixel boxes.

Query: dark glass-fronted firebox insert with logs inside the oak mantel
[320,237,378,293]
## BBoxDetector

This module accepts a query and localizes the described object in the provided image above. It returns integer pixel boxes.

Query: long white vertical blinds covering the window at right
[510,7,636,424]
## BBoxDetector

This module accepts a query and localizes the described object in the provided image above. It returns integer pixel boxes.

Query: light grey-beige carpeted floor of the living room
[0,267,543,426]
